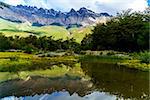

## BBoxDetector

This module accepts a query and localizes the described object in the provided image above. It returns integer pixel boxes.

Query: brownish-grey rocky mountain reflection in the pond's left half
[0,75,92,98]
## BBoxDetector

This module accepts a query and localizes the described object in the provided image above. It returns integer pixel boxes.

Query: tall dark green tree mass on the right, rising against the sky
[91,10,149,52]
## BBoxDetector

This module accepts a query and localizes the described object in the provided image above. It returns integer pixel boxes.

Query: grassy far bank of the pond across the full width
[0,51,150,72]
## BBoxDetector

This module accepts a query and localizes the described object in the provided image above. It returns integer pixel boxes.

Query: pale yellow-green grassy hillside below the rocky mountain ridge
[0,19,92,43]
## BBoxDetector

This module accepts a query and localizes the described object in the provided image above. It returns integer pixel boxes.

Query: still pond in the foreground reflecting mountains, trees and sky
[0,61,150,100]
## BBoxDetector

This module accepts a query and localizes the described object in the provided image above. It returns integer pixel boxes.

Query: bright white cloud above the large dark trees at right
[95,0,148,14]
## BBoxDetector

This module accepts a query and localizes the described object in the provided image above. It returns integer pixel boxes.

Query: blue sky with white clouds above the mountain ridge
[0,0,150,15]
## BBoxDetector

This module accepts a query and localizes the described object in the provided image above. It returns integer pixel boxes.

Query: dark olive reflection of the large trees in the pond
[81,62,149,99]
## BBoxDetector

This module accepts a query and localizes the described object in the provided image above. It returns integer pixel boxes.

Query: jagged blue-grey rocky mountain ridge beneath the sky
[0,2,110,26]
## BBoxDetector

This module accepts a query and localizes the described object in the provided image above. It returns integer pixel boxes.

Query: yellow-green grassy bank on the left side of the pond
[0,52,77,72]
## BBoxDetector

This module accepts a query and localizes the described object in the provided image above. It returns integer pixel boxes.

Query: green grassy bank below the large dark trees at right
[80,51,150,71]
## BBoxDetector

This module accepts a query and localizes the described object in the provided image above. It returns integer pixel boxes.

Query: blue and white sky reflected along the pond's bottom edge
[2,91,116,100]
